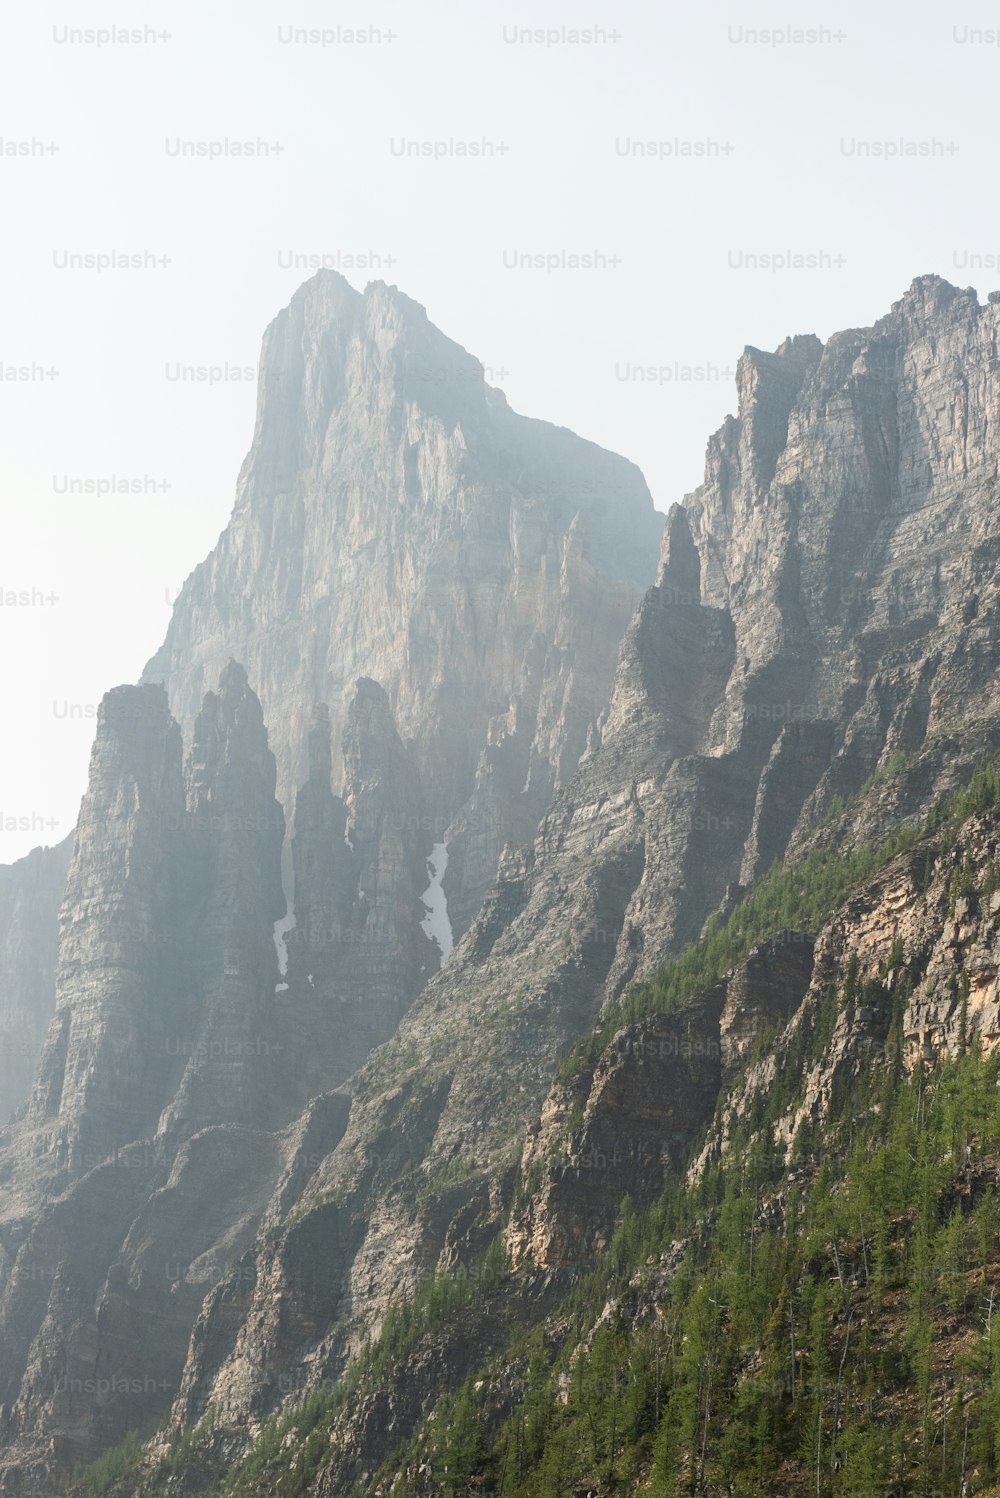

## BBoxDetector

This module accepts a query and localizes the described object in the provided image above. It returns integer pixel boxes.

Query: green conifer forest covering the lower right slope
[353,1047,1000,1498]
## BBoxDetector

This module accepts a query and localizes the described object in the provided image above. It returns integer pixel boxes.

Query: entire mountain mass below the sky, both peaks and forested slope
[0,277,1000,1498]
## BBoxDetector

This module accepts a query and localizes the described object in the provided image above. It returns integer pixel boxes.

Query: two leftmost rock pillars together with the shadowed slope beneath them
[0,662,300,1465]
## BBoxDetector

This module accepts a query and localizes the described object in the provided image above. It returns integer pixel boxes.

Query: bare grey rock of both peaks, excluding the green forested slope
[9,274,1000,1494]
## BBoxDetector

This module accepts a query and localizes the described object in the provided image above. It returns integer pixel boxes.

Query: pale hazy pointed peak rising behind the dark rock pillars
[138,273,662,929]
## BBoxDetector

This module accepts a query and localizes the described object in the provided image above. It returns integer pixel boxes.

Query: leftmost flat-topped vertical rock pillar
[28,686,184,1174]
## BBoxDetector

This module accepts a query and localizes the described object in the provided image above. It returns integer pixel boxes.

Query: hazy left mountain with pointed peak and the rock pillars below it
[0,273,663,1488]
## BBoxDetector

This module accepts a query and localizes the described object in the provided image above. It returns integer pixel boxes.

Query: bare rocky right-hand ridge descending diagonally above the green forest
[132,277,1000,1480]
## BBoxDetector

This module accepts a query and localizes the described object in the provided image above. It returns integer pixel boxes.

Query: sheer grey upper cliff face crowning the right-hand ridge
[689,277,1000,789]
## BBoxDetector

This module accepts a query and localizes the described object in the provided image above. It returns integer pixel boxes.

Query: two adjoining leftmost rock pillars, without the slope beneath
[6,662,284,1189]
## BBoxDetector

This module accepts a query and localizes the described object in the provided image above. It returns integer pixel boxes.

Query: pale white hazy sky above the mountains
[0,0,1000,861]
